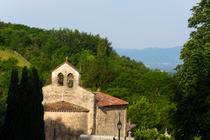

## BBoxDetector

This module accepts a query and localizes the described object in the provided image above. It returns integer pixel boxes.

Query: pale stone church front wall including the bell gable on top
[43,62,95,134]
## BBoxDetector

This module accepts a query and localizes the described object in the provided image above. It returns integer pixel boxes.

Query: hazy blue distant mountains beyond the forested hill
[115,46,182,73]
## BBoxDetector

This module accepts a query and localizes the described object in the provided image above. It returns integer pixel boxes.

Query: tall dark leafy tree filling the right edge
[174,0,210,140]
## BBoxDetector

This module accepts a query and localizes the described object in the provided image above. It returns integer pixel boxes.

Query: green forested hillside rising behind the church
[0,22,176,137]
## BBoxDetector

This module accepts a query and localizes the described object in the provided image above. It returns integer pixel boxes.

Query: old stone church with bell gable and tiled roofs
[43,62,128,140]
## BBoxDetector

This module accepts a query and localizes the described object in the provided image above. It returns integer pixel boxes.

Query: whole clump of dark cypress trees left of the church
[0,67,45,140]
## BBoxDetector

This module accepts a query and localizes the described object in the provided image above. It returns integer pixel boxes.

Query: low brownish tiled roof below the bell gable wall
[44,101,89,112]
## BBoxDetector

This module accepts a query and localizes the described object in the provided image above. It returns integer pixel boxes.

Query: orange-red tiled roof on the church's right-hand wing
[96,92,128,107]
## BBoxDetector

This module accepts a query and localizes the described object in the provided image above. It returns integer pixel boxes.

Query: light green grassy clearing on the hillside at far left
[0,49,30,67]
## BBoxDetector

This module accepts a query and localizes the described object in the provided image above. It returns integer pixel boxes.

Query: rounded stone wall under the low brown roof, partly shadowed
[44,112,88,140]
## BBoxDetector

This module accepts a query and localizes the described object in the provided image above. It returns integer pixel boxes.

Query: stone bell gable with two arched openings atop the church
[52,62,80,88]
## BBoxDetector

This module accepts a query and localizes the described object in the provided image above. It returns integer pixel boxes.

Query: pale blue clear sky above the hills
[0,0,199,49]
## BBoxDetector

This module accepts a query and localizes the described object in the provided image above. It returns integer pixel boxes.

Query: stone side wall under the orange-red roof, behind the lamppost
[96,106,127,137]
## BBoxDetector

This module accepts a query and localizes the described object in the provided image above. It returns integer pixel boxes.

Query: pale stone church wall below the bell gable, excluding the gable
[43,85,95,134]
